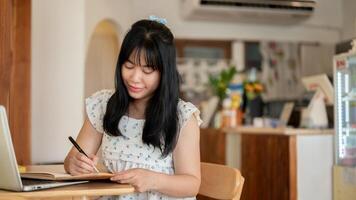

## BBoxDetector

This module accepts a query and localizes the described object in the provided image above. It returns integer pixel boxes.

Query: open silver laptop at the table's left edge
[0,105,88,191]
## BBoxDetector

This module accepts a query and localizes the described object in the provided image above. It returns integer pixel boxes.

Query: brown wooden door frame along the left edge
[0,0,31,164]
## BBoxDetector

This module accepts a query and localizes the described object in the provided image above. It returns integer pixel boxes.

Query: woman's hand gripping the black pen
[65,152,98,175]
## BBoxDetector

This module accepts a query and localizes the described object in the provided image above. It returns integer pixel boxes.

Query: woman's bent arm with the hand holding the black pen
[64,117,103,175]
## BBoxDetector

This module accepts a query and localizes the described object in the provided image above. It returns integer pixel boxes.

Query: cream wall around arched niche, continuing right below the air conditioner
[31,0,342,163]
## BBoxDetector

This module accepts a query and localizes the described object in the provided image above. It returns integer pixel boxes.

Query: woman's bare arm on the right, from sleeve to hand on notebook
[111,116,200,197]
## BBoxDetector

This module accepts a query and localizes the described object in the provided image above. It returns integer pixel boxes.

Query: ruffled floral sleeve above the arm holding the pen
[85,90,114,133]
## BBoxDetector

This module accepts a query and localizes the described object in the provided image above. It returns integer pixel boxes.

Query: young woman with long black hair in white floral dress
[64,20,201,199]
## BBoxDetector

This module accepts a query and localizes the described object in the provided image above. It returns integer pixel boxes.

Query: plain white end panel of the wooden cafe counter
[296,135,334,200]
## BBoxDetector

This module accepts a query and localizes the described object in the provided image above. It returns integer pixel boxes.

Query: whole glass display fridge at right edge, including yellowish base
[333,41,356,200]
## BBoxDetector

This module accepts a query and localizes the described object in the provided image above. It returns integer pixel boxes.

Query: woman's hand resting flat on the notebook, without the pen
[110,168,159,192]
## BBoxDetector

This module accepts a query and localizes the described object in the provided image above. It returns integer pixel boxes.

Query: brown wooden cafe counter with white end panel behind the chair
[201,127,334,200]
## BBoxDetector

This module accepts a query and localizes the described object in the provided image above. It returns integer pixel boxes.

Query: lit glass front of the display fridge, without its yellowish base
[334,50,356,167]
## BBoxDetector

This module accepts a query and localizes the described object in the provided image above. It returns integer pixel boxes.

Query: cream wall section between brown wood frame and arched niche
[31,0,85,163]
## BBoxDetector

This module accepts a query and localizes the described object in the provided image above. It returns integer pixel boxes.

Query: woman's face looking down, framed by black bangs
[121,51,160,100]
